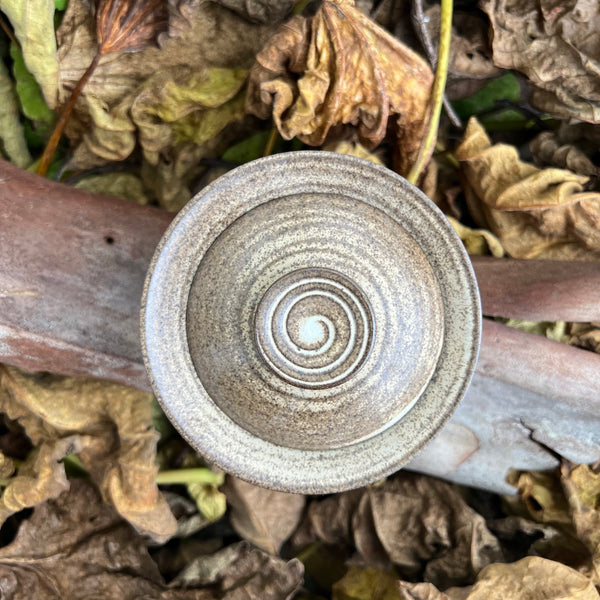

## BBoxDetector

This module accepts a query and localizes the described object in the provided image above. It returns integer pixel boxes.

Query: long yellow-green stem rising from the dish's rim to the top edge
[407,0,453,184]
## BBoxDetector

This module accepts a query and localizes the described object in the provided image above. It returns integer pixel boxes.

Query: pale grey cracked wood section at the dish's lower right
[408,320,600,493]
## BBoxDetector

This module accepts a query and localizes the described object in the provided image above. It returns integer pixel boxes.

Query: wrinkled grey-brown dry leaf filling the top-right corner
[480,0,600,123]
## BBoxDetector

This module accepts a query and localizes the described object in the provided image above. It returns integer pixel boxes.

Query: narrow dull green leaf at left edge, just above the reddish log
[0,59,31,168]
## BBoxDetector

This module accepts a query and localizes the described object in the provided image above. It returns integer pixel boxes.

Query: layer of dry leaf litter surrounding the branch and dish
[0,0,600,600]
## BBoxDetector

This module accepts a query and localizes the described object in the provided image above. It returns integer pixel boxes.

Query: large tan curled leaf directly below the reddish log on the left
[0,366,176,541]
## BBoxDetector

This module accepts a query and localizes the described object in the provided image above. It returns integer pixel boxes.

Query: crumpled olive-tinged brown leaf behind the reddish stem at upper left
[57,0,278,210]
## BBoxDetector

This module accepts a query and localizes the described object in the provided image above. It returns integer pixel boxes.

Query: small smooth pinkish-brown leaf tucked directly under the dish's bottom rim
[223,477,306,554]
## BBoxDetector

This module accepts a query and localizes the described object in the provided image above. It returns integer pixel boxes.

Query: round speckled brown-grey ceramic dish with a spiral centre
[142,152,481,493]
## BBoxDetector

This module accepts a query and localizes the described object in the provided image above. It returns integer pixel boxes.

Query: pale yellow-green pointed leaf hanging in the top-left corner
[0,0,58,108]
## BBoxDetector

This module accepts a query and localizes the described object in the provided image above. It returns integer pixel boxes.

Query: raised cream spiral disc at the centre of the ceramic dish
[255,268,374,388]
